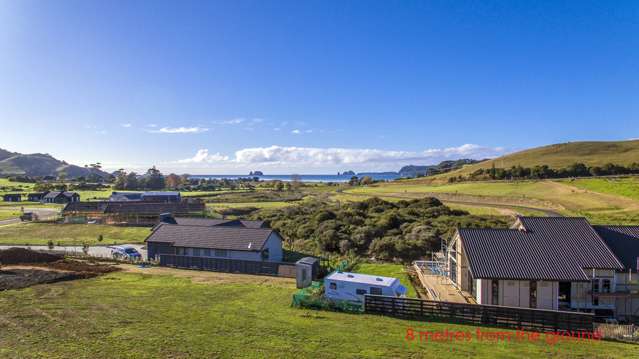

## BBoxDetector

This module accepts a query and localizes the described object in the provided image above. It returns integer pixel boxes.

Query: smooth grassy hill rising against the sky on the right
[437,140,639,178]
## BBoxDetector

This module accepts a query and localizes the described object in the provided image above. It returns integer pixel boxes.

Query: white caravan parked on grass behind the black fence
[324,272,406,303]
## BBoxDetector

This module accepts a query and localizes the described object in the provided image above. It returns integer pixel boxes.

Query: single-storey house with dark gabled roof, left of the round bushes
[146,221,283,262]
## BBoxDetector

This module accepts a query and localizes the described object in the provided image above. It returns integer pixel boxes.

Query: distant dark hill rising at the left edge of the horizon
[0,149,109,178]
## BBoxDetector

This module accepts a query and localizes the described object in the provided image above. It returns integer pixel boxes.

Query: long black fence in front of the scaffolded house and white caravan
[364,295,594,332]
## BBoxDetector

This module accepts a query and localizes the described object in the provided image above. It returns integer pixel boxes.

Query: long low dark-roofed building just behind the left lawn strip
[62,201,206,226]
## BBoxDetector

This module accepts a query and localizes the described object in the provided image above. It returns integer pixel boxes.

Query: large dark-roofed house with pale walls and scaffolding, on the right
[446,217,624,315]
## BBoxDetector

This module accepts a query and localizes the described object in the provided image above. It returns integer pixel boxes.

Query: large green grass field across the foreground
[0,268,637,358]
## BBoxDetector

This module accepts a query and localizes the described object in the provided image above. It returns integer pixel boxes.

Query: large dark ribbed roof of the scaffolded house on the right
[458,217,623,281]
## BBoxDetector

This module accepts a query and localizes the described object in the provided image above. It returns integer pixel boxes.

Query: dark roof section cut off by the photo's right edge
[594,226,639,272]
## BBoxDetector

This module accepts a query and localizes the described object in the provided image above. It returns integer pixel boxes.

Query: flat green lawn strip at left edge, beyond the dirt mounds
[0,223,150,245]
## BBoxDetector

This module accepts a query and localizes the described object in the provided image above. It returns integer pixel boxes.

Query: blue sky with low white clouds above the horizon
[0,0,639,174]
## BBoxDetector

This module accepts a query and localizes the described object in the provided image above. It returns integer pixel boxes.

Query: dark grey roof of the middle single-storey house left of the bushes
[146,224,273,252]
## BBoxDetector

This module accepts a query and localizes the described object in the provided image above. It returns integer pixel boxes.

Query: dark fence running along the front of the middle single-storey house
[160,254,295,276]
